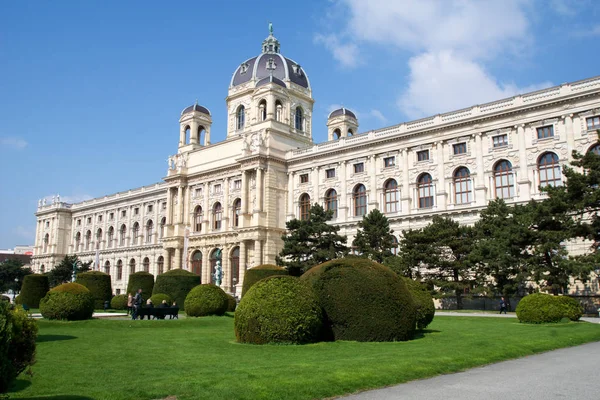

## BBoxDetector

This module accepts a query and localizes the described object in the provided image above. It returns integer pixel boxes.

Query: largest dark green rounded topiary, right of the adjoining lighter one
[300,257,416,342]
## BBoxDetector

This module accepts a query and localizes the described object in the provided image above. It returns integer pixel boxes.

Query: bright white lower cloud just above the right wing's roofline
[398,51,551,118]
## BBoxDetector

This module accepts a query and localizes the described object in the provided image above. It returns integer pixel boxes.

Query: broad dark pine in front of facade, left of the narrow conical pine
[277,203,348,276]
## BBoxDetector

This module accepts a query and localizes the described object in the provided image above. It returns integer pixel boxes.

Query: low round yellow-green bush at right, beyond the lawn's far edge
[516,293,567,324]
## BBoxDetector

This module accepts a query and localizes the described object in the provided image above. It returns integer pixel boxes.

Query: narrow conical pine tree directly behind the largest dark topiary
[352,209,397,263]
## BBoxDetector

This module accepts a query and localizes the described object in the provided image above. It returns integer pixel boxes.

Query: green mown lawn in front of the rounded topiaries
[10,316,600,400]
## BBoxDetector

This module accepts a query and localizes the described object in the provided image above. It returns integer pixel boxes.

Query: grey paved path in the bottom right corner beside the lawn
[342,340,600,400]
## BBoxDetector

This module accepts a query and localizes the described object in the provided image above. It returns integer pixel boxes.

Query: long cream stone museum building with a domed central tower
[32,31,600,295]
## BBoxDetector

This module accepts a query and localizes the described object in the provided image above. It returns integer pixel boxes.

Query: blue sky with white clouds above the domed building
[0,0,600,249]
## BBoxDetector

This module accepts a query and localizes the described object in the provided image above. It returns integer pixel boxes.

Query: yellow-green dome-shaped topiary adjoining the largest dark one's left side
[234,276,323,344]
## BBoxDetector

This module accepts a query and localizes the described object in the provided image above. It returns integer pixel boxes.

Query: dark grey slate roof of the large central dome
[231,53,310,88]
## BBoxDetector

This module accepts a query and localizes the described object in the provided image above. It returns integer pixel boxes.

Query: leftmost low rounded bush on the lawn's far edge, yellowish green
[40,282,94,321]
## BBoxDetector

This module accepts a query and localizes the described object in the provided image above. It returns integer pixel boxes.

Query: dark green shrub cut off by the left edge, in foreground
[0,301,38,397]
